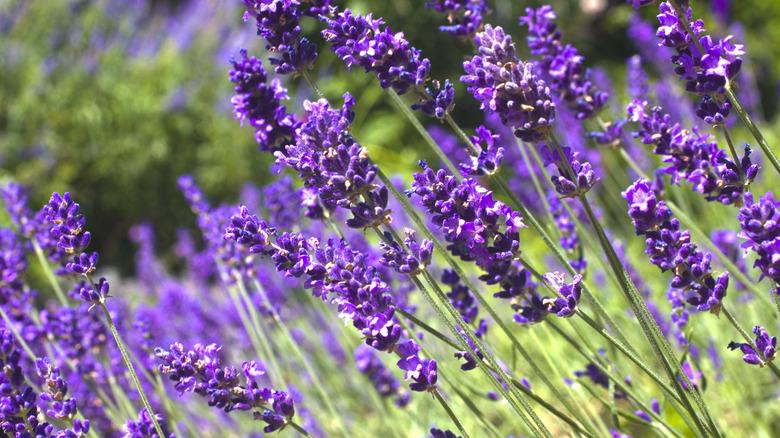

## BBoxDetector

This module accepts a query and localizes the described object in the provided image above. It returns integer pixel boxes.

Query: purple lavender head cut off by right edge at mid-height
[738,193,780,294]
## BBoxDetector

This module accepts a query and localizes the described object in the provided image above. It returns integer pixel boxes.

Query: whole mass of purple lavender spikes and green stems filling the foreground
[0,0,780,438]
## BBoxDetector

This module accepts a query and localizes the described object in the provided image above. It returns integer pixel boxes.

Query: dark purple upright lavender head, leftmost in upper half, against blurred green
[230,49,297,151]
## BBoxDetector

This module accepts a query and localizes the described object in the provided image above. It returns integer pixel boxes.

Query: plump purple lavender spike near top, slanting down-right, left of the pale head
[322,9,430,94]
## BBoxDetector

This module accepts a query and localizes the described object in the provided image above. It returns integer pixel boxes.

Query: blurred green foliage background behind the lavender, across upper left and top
[0,0,780,270]
